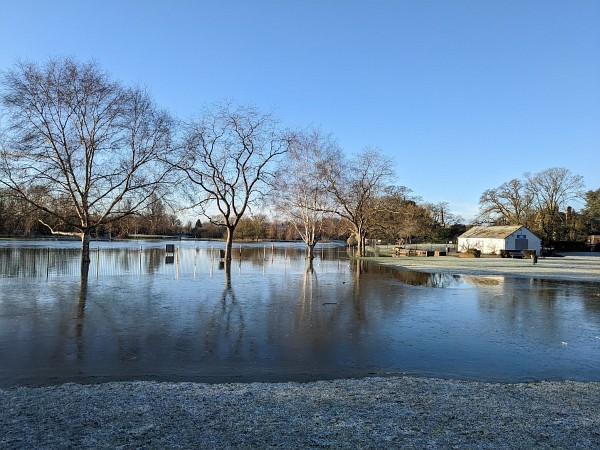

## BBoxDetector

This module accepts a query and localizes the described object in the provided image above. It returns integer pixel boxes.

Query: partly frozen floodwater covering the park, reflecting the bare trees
[0,241,600,386]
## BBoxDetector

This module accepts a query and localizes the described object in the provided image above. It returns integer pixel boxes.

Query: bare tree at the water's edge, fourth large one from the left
[323,149,394,257]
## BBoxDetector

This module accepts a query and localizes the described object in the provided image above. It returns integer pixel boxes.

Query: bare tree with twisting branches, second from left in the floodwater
[174,103,289,263]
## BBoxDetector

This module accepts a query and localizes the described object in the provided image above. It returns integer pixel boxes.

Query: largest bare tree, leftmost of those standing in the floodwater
[0,59,172,273]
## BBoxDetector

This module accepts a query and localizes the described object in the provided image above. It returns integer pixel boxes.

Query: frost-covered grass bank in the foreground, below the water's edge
[0,377,600,449]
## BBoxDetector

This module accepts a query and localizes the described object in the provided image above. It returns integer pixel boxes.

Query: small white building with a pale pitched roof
[458,225,542,255]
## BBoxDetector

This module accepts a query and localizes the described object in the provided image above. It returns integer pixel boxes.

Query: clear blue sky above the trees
[0,0,600,220]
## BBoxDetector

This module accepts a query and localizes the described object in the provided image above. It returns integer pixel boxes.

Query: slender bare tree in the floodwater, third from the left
[271,130,338,268]
